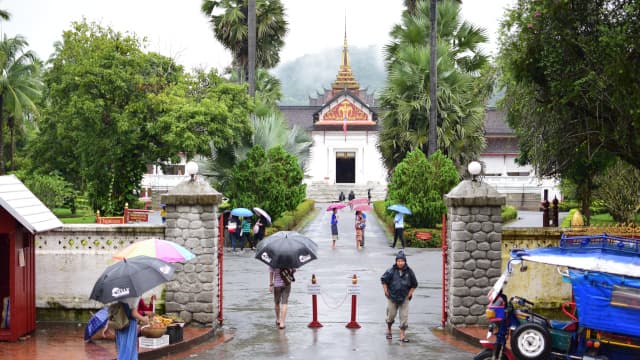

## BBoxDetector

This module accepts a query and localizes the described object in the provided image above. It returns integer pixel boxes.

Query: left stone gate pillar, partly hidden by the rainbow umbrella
[161,178,222,326]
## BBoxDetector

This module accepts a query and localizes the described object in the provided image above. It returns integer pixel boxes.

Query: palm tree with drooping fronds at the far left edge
[0,35,42,175]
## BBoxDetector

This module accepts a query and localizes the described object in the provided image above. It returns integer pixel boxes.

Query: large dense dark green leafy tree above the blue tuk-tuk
[499,0,640,221]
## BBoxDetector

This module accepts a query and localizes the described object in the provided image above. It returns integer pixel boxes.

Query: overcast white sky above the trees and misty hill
[0,0,513,69]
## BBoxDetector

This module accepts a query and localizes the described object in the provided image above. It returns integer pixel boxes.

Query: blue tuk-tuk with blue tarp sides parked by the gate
[474,234,640,360]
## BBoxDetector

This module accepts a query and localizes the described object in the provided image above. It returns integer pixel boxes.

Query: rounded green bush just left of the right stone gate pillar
[386,150,459,228]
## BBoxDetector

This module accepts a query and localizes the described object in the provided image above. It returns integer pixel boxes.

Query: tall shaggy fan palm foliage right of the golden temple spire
[378,0,494,169]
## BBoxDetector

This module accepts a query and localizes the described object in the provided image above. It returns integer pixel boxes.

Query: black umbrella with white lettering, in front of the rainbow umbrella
[89,256,175,304]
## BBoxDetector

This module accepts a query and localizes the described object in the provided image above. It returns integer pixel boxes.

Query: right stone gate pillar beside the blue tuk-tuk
[445,180,506,327]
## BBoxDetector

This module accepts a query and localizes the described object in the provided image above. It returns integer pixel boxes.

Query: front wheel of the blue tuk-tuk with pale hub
[510,323,551,360]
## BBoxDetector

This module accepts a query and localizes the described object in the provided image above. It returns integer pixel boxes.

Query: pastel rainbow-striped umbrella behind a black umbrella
[113,239,196,262]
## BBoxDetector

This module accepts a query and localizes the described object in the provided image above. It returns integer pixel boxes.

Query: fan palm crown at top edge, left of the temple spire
[201,0,289,82]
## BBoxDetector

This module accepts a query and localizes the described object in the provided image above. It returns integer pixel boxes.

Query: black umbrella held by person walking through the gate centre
[256,231,318,268]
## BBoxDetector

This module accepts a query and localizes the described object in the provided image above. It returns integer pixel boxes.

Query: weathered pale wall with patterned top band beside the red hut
[35,224,165,309]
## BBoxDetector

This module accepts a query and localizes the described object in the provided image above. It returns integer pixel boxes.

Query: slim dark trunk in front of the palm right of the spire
[427,0,438,156]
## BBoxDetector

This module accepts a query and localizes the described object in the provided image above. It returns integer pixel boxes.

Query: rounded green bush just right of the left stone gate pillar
[224,146,306,219]
